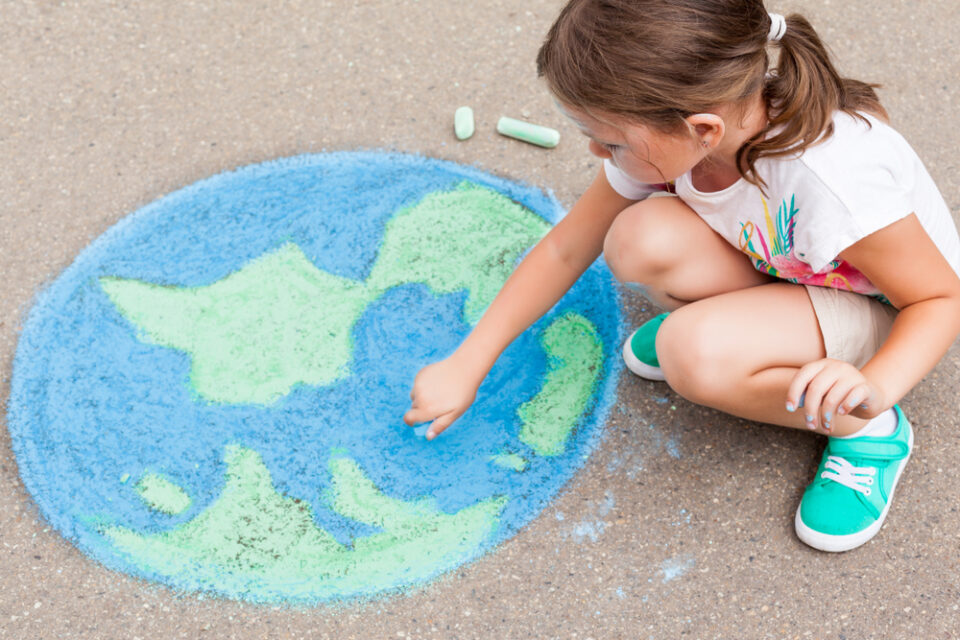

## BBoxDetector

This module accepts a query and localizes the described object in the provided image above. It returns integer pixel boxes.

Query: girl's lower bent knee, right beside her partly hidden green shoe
[656,304,730,406]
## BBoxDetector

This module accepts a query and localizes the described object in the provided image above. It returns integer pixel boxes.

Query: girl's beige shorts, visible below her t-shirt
[804,285,899,368]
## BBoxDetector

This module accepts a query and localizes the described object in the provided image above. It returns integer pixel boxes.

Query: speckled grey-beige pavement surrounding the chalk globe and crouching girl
[0,0,960,639]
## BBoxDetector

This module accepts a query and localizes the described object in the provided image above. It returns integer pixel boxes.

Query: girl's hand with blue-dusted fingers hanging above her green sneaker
[787,358,887,432]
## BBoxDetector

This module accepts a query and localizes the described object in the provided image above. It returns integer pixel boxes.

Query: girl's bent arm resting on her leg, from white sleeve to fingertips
[787,214,960,424]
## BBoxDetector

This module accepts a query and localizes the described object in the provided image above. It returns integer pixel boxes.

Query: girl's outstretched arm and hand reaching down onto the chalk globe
[403,168,633,439]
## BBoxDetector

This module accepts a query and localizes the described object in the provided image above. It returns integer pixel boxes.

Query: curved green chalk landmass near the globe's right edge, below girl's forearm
[517,312,603,456]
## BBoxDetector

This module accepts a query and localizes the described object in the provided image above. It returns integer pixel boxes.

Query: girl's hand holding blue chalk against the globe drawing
[403,356,483,440]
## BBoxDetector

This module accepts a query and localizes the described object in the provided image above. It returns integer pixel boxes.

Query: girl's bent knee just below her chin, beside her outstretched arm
[603,198,686,284]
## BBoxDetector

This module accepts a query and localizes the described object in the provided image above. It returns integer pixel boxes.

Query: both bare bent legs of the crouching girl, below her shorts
[604,198,866,436]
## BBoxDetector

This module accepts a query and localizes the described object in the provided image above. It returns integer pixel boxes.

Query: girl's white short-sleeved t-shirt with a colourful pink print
[604,111,960,298]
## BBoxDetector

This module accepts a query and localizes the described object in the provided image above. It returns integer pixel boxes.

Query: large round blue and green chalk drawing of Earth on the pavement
[8,152,621,603]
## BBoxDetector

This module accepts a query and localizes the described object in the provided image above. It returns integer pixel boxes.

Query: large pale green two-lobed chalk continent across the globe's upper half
[100,182,549,405]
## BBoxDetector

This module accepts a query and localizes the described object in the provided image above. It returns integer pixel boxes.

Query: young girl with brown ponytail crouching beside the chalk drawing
[404,0,960,551]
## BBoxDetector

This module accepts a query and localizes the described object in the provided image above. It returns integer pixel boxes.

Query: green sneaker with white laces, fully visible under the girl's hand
[795,406,913,551]
